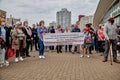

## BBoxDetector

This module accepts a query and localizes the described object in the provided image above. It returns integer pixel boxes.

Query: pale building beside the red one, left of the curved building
[79,15,93,30]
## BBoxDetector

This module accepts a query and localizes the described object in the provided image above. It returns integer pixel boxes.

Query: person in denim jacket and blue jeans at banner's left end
[37,20,48,59]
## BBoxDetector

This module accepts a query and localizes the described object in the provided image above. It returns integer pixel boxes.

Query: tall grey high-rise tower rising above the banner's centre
[56,8,71,29]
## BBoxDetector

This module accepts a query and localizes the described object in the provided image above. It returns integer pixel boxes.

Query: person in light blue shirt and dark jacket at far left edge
[0,21,10,66]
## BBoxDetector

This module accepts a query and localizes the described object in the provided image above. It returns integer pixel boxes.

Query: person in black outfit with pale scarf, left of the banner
[22,21,32,57]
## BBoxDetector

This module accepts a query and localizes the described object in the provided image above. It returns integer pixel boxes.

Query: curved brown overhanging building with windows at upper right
[94,0,120,28]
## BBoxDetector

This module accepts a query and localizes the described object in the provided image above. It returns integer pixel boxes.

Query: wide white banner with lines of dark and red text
[43,32,84,46]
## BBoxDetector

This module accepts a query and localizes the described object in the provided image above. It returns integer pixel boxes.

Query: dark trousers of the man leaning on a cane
[104,40,117,60]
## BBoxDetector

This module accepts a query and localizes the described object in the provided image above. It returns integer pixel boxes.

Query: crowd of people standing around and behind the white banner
[0,18,120,67]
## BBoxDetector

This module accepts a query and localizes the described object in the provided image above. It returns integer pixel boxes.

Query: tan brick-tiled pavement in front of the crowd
[0,52,120,80]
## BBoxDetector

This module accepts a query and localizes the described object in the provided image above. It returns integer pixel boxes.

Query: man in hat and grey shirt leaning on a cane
[103,17,120,63]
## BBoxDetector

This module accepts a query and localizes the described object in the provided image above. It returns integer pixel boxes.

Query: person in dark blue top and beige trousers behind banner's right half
[72,24,81,54]
